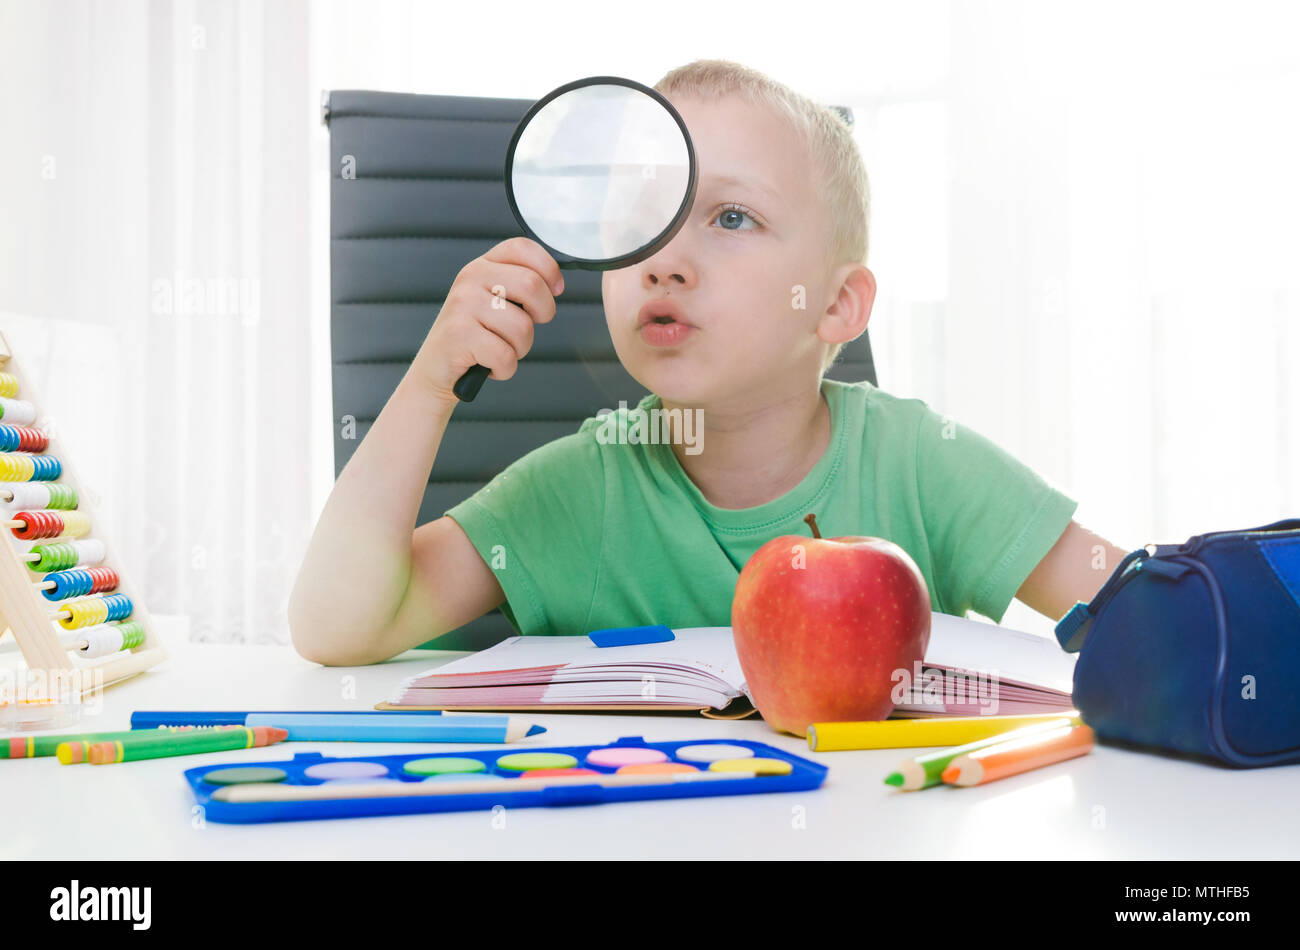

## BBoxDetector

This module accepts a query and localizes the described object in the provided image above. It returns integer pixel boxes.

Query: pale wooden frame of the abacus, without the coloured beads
[0,333,166,693]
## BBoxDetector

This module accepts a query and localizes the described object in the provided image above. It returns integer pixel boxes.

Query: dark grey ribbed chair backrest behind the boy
[322,91,876,650]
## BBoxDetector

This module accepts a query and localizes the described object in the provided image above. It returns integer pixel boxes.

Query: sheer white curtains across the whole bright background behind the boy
[0,0,1300,642]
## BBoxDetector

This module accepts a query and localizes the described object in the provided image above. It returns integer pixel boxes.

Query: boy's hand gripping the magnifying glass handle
[411,238,564,407]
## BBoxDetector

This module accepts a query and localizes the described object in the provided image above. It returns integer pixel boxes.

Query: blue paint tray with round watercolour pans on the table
[185,736,828,824]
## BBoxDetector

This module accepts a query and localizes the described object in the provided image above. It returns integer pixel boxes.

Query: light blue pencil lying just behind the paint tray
[244,712,546,742]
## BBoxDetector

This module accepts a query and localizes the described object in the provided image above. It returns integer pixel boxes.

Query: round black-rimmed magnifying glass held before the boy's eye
[452,75,696,403]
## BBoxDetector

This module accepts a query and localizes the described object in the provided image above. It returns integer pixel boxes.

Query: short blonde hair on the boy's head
[654,60,871,373]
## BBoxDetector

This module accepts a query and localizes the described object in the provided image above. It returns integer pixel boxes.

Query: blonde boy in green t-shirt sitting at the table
[290,60,1125,665]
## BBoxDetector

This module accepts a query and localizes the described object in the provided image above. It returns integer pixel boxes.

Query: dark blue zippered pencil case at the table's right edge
[1056,519,1300,768]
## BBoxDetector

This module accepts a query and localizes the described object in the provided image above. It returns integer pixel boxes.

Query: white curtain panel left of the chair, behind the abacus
[0,0,313,643]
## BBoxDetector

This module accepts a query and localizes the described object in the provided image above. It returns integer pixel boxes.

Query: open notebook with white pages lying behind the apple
[374,613,1075,719]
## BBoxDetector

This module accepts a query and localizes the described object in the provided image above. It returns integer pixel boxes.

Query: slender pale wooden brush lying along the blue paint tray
[212,772,755,802]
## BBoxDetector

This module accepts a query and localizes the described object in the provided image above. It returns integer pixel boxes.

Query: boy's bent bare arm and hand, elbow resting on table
[289,237,564,665]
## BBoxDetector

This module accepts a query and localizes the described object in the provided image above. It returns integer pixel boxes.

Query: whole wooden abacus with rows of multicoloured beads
[0,333,166,691]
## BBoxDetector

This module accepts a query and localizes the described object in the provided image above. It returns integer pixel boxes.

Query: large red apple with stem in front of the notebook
[732,515,930,736]
